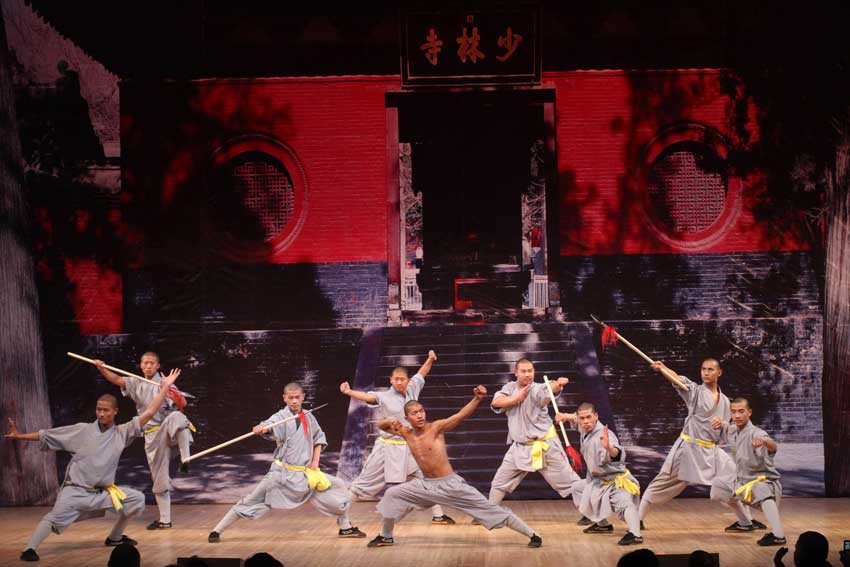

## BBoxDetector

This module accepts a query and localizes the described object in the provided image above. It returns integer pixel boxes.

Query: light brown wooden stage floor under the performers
[0,498,850,567]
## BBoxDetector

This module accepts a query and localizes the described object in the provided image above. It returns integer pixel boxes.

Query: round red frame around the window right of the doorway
[638,123,741,250]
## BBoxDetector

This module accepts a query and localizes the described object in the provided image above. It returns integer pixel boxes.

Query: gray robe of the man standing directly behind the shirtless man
[351,374,425,498]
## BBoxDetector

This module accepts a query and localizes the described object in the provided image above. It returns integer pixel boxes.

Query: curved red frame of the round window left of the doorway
[207,134,307,258]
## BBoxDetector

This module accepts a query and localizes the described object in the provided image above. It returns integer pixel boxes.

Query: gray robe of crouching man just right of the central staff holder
[573,422,640,522]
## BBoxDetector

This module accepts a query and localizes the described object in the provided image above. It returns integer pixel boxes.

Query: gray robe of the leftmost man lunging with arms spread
[38,417,145,534]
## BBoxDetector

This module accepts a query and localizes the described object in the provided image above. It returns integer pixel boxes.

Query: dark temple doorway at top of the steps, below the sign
[400,97,543,309]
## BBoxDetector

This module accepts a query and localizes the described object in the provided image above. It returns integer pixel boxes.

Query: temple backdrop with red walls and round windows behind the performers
[0,0,850,504]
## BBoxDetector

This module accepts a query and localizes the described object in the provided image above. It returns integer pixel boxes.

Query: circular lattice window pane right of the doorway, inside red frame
[647,142,727,235]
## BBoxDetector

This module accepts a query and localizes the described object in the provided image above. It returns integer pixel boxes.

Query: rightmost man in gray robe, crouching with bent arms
[711,398,786,546]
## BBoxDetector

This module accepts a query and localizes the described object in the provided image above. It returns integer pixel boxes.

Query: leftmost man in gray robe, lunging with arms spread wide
[6,370,180,561]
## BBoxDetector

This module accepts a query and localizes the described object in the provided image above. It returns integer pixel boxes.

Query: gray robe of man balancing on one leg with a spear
[121,372,193,494]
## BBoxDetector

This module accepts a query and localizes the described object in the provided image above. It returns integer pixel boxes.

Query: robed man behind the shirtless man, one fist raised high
[339,350,455,524]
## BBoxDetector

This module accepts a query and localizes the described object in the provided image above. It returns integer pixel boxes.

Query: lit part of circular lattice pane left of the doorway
[227,152,295,242]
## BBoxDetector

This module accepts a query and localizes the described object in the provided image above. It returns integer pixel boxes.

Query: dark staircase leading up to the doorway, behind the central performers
[340,323,608,499]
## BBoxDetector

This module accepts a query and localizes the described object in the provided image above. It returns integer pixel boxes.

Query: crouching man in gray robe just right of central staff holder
[555,402,643,545]
